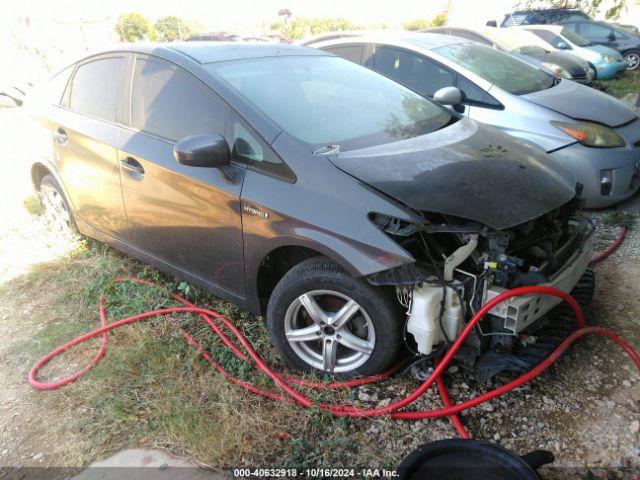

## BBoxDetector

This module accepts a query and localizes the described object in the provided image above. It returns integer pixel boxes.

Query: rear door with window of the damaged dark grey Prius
[51,54,128,236]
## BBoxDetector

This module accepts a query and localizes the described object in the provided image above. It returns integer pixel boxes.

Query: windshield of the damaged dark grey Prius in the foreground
[208,55,453,151]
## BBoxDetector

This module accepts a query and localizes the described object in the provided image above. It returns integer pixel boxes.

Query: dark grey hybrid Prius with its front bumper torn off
[25,42,593,377]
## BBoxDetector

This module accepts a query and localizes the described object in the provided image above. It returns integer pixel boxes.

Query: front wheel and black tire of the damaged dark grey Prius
[267,257,403,378]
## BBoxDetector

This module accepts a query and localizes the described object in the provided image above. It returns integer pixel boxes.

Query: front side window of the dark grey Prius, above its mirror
[131,57,227,141]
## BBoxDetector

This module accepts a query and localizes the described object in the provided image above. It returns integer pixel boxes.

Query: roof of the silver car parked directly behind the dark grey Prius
[302,30,468,50]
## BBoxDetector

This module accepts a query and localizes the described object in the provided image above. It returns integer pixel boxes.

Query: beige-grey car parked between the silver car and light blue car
[424,27,595,85]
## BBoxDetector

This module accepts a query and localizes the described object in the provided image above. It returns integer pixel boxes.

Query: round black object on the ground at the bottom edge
[397,438,554,480]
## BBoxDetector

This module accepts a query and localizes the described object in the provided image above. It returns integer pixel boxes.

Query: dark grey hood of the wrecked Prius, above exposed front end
[328,119,575,230]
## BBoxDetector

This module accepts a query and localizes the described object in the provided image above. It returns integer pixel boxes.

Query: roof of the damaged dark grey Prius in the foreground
[90,41,328,64]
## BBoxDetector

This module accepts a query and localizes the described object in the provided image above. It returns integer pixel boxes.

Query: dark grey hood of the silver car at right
[522,80,638,127]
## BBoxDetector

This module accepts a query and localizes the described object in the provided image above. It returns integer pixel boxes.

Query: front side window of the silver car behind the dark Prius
[373,47,455,97]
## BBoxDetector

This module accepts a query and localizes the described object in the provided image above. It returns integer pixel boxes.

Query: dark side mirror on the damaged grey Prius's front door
[173,133,231,168]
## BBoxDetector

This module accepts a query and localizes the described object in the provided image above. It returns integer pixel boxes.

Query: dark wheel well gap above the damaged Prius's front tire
[257,245,324,315]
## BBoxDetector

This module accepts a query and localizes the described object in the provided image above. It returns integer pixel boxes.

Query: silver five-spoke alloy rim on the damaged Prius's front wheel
[284,290,376,373]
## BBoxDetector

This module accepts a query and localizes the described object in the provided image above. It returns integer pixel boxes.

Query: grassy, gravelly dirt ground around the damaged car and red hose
[0,103,640,479]
